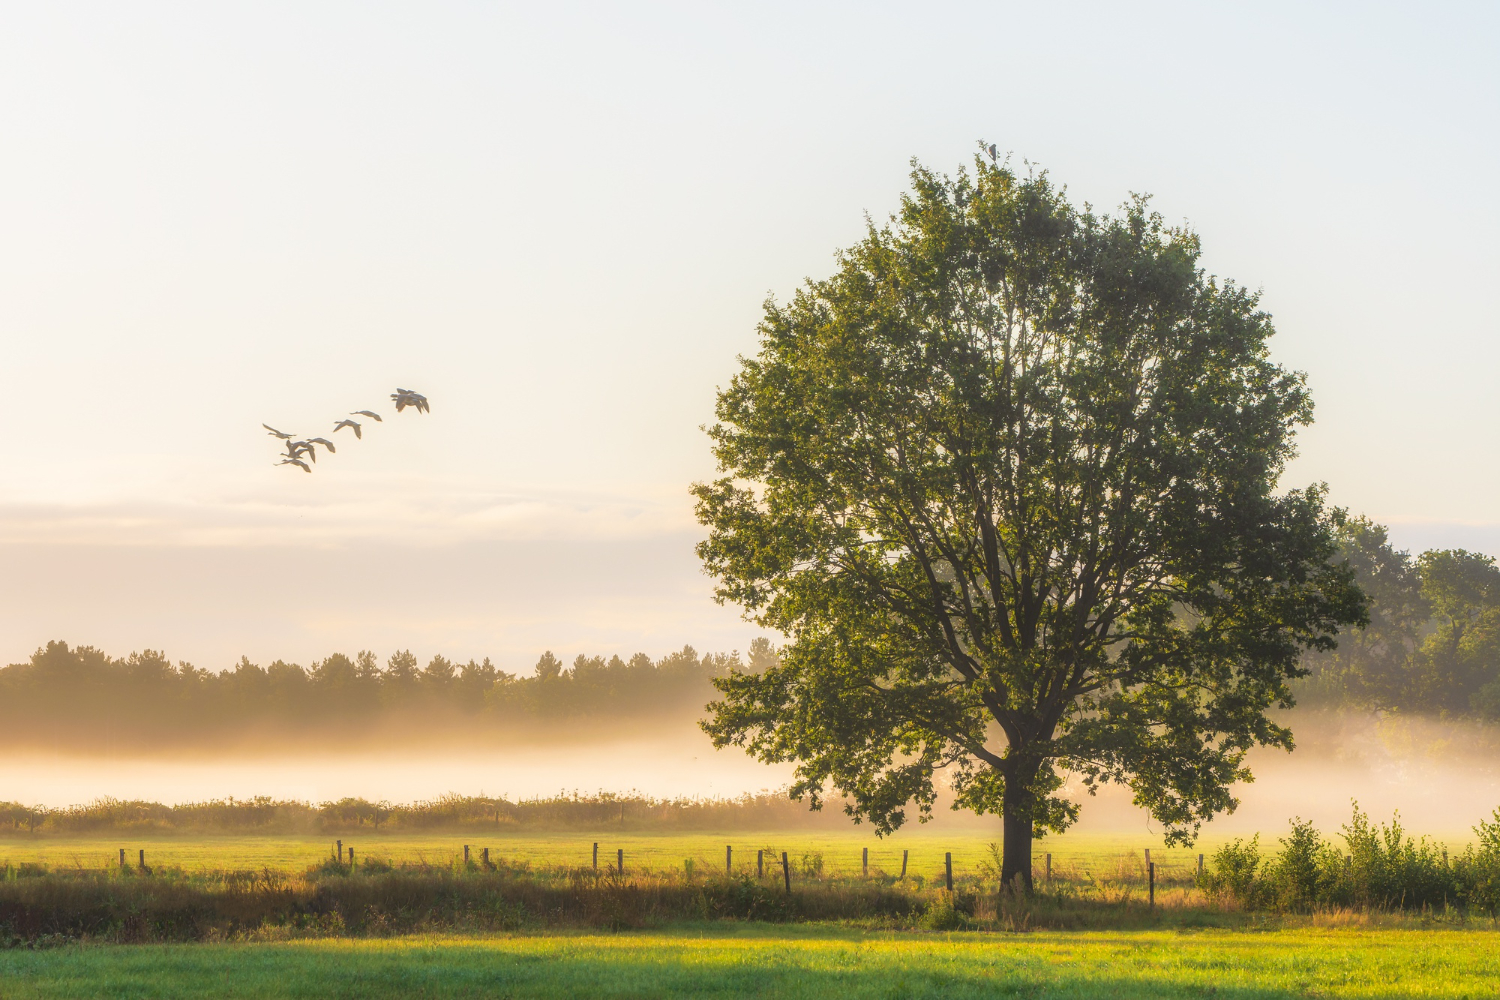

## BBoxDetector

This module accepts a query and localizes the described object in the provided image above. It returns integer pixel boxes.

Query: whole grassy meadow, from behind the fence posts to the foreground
[0,829,1500,1000]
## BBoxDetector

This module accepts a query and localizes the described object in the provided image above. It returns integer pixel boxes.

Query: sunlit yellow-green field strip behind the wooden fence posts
[0,829,1338,880]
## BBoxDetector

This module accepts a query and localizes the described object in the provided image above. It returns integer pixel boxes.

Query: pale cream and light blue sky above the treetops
[0,1,1500,672]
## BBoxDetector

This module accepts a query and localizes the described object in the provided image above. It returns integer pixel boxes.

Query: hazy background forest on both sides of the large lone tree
[0,517,1500,750]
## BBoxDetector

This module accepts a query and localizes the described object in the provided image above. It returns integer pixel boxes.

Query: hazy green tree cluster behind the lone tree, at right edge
[1299,517,1500,721]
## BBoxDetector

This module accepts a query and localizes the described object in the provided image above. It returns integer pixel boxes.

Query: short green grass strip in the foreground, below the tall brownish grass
[0,925,1500,1000]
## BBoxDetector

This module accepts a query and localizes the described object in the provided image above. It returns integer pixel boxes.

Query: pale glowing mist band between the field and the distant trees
[0,711,1500,843]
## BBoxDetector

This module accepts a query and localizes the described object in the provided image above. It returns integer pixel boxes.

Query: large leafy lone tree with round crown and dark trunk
[693,159,1364,888]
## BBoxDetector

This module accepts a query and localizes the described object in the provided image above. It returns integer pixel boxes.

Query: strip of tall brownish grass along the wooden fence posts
[0,856,1242,948]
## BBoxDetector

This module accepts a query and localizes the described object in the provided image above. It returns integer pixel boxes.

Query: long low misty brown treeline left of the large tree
[0,639,776,748]
